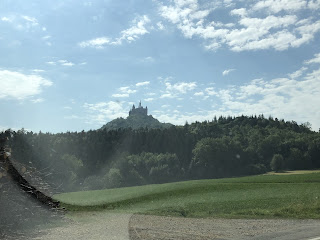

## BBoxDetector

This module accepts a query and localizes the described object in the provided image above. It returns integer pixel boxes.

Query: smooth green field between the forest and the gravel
[54,173,320,219]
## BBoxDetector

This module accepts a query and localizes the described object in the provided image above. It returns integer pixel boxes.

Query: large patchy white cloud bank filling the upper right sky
[159,0,320,52]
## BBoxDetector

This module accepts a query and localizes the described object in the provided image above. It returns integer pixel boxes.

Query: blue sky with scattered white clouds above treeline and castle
[0,0,320,133]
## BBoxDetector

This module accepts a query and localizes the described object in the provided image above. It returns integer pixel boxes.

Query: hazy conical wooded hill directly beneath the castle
[100,114,172,131]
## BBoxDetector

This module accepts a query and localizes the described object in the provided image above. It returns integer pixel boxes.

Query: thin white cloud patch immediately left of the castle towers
[83,101,128,125]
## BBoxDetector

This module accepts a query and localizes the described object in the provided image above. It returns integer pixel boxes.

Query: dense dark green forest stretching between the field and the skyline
[1,115,320,191]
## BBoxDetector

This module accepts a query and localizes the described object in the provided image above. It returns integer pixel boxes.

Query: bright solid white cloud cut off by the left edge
[0,70,52,100]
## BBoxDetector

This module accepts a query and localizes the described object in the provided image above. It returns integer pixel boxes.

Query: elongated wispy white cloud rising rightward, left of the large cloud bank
[79,15,150,49]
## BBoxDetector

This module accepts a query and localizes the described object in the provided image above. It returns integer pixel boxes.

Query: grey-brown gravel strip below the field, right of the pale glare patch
[129,215,320,240]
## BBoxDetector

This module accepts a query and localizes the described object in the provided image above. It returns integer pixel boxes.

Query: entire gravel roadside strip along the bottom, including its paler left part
[23,211,320,240]
